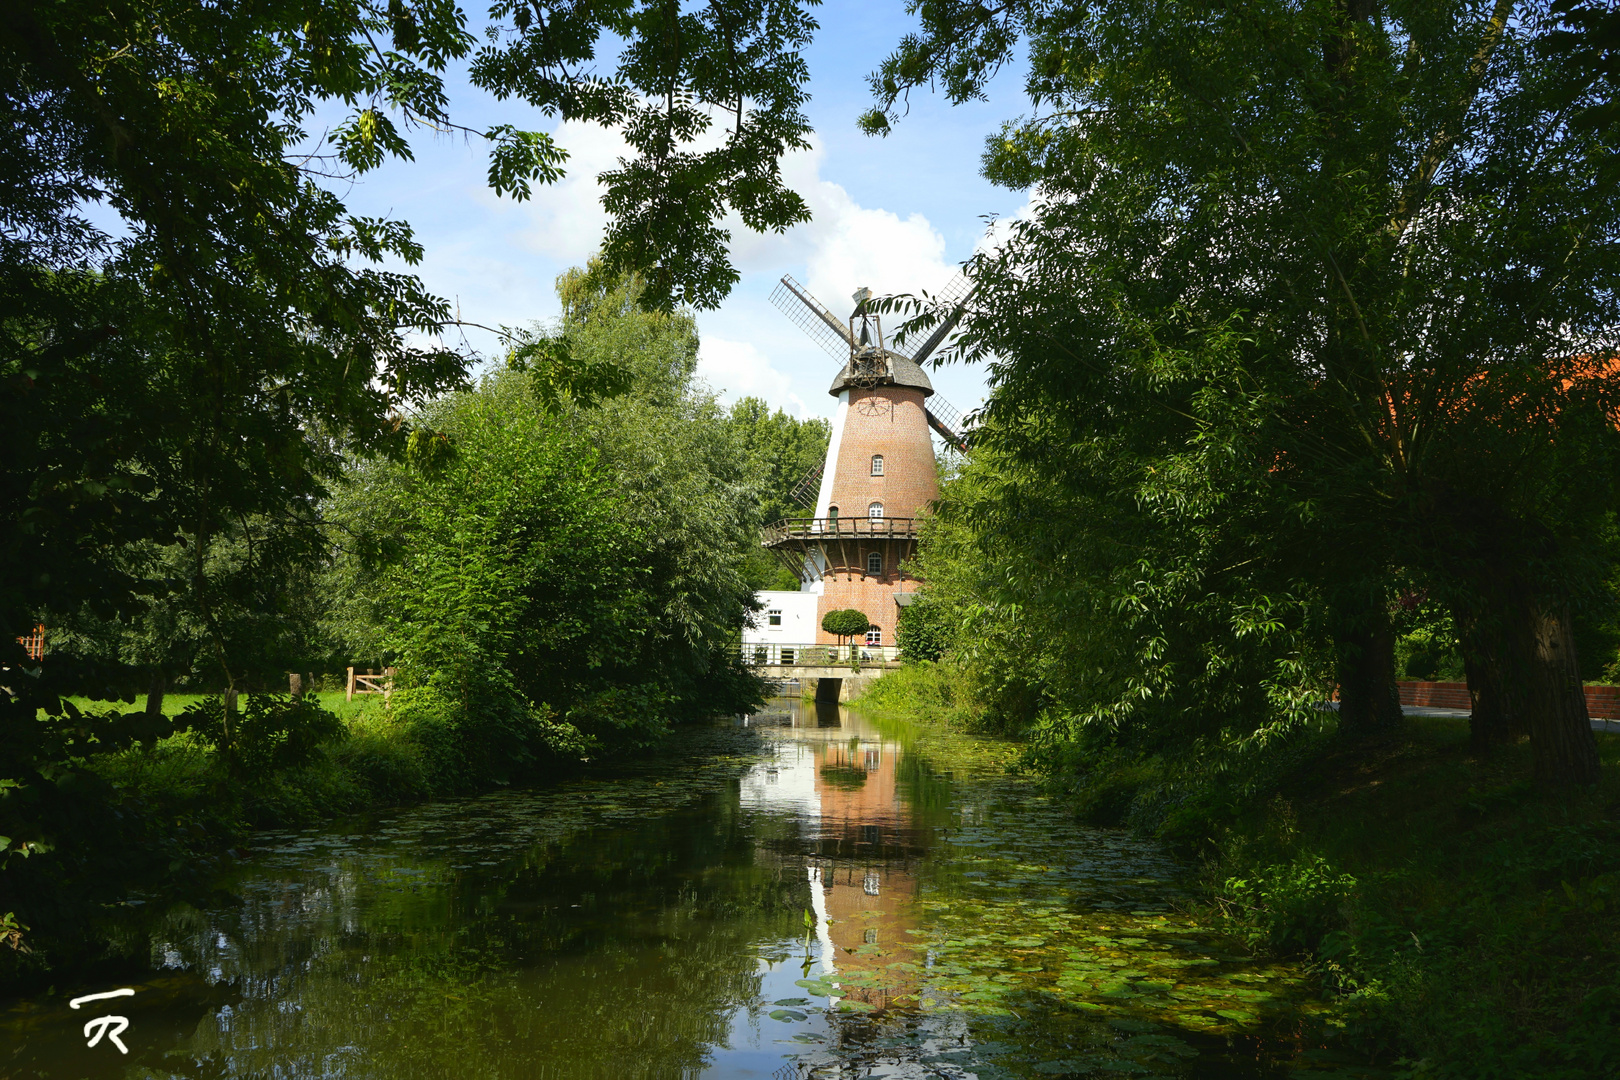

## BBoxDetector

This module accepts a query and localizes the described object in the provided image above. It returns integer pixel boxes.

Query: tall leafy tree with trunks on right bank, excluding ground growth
[865,0,1620,785]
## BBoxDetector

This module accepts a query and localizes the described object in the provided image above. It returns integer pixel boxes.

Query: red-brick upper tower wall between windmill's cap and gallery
[833,387,940,518]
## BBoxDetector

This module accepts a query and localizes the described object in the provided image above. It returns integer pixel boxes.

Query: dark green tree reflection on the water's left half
[136,786,804,1080]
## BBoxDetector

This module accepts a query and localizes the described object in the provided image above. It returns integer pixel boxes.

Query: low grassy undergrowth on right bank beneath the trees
[857,661,1620,1078]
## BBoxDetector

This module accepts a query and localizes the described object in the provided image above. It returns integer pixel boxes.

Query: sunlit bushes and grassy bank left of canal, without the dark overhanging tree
[0,266,825,978]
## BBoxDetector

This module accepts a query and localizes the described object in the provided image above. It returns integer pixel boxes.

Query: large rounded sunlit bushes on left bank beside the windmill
[329,272,765,789]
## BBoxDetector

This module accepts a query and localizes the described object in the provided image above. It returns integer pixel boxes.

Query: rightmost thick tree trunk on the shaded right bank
[1528,604,1597,790]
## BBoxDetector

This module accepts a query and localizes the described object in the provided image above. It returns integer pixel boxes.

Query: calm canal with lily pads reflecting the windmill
[0,699,1380,1080]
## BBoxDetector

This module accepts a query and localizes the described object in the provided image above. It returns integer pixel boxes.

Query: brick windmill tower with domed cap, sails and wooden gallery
[763,277,966,646]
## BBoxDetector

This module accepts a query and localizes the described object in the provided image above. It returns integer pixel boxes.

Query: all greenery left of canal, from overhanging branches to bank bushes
[0,0,815,981]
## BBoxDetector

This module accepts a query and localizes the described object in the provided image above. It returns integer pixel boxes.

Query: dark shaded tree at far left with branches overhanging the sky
[0,0,815,965]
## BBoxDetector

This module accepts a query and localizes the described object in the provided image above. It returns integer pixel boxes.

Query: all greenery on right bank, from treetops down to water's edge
[865,0,1620,1077]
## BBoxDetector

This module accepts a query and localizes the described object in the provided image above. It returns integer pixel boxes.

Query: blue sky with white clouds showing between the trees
[335,0,1025,416]
